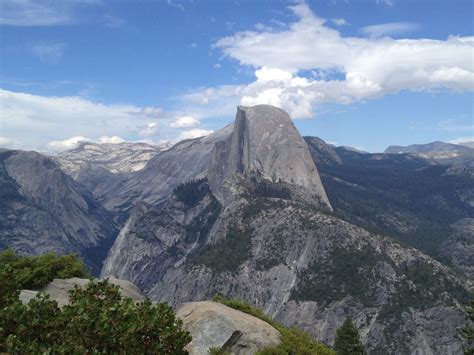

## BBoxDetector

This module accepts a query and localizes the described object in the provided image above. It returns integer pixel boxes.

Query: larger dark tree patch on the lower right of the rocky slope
[291,245,383,305]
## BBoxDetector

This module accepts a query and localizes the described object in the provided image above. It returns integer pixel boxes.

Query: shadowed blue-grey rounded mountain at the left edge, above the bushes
[0,150,117,274]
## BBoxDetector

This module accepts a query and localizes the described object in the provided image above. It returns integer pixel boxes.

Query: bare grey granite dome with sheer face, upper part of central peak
[208,105,331,209]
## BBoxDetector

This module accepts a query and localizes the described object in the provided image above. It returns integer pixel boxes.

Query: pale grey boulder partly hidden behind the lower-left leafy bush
[20,277,145,307]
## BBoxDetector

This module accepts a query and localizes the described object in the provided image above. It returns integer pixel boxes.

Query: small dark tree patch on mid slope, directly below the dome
[194,226,252,272]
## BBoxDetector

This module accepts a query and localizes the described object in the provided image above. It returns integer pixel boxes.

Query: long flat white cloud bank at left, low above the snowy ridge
[0,89,176,151]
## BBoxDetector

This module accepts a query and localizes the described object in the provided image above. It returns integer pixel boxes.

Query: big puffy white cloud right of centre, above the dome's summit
[184,3,474,118]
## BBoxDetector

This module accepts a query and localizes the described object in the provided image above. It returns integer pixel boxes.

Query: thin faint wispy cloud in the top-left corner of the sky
[0,0,100,26]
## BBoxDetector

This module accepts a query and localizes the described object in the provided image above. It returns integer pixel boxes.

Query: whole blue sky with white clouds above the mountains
[0,0,474,154]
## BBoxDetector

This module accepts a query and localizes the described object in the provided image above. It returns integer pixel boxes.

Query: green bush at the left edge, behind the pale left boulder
[0,250,90,294]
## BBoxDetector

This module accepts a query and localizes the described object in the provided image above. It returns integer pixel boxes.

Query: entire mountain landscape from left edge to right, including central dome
[0,105,474,354]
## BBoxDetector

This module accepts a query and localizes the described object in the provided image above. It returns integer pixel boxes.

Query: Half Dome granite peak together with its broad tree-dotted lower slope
[103,106,468,354]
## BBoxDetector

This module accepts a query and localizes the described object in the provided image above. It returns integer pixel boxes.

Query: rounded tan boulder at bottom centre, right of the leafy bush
[177,301,280,355]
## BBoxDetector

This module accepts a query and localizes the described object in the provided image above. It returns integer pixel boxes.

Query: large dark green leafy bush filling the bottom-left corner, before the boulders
[0,270,191,355]
